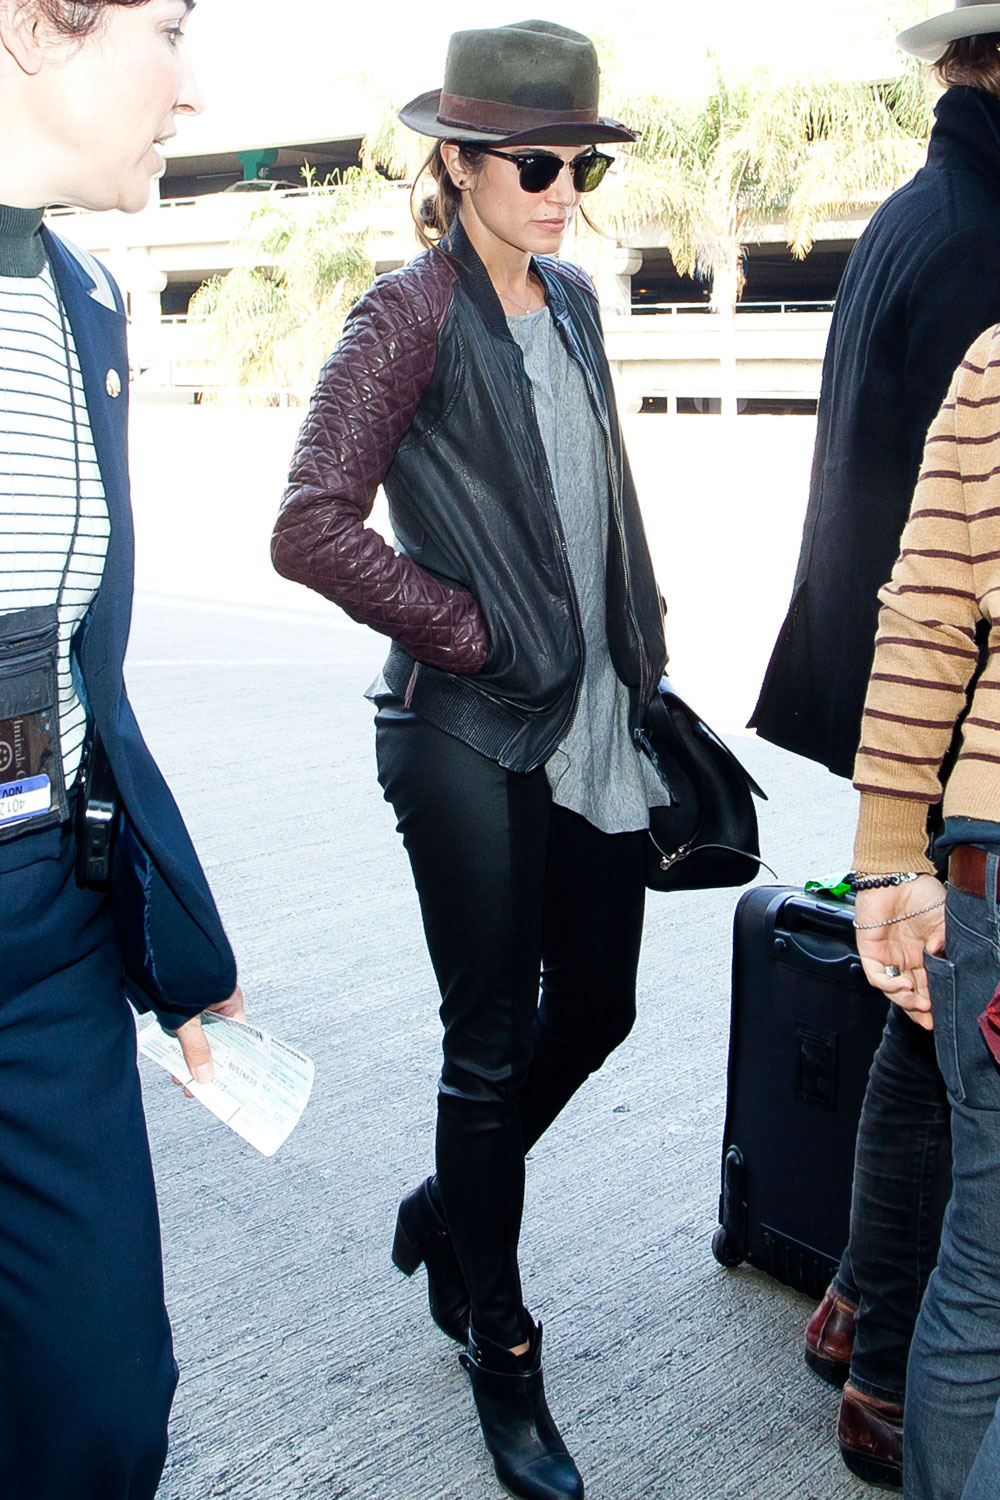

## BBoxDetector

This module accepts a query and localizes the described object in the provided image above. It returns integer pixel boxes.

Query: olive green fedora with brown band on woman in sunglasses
[399,21,636,146]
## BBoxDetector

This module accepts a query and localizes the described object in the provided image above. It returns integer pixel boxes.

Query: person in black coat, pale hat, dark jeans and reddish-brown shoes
[750,0,1000,1488]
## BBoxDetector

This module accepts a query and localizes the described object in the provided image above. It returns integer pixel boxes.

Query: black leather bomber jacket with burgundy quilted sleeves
[271,222,666,773]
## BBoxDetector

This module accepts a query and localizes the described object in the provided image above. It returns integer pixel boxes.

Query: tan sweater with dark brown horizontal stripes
[855,326,1000,873]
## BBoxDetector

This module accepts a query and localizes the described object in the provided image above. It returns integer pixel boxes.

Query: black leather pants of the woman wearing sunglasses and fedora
[375,699,645,1347]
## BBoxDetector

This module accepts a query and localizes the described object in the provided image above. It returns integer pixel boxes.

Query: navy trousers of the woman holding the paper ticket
[0,827,177,1500]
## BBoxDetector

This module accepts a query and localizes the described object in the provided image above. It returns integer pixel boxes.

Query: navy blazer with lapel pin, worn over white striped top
[39,230,235,1026]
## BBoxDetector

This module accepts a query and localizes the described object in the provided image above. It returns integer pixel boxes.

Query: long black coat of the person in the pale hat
[750,87,1000,776]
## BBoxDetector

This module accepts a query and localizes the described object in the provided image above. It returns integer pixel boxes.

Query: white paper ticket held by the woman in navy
[138,1011,315,1157]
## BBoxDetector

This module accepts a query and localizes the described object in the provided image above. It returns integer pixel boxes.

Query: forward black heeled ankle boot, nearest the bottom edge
[459,1323,583,1500]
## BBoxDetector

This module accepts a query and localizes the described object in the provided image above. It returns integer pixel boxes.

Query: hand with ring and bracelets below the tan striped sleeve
[855,875,945,1031]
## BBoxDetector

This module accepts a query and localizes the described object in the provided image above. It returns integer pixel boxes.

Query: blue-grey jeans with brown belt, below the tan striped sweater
[904,876,1000,1500]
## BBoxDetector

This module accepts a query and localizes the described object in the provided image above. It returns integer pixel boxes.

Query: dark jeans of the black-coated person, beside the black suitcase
[835,1005,951,1403]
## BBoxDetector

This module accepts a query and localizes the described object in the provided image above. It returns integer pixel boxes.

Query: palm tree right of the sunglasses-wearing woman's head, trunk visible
[601,65,931,413]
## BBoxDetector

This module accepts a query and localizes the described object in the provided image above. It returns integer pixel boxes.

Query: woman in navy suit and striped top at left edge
[0,0,243,1500]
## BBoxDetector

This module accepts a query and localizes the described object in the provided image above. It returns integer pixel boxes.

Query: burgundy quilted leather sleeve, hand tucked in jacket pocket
[271,257,489,675]
